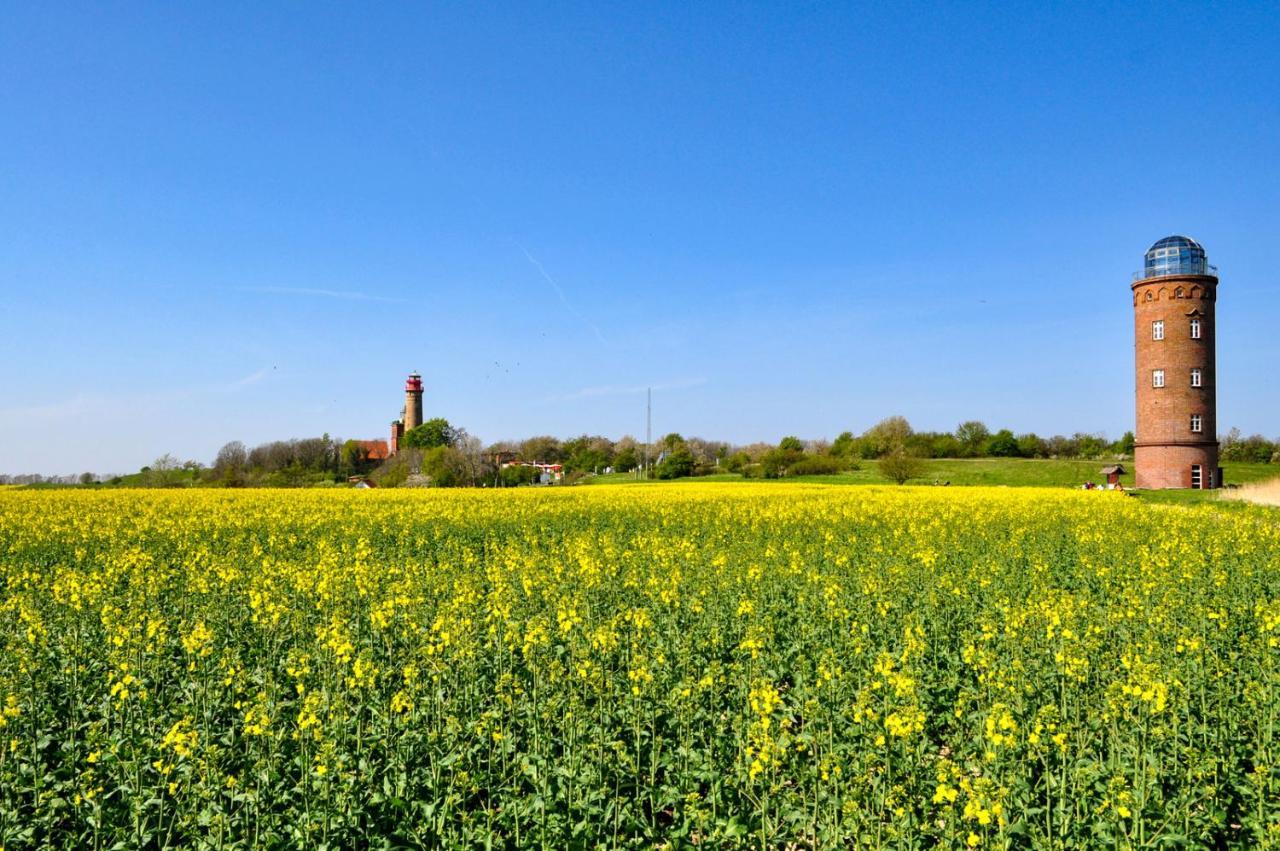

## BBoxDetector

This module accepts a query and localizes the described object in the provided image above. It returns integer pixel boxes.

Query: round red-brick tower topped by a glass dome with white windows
[1133,237,1222,489]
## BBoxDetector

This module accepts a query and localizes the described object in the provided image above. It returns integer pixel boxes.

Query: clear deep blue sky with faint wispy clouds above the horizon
[0,3,1280,473]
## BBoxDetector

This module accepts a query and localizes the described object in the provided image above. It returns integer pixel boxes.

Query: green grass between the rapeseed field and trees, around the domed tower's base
[588,458,1280,491]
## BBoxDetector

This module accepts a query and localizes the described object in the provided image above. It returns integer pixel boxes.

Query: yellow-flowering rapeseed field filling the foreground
[0,484,1280,851]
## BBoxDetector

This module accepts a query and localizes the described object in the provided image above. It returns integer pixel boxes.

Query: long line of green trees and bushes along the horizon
[12,416,1280,488]
